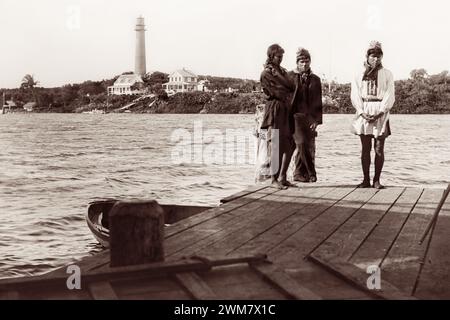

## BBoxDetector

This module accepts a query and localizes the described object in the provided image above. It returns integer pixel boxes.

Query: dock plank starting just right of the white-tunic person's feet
[314,188,404,261]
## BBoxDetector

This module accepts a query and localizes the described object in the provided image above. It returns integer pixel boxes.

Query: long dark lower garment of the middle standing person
[294,113,316,179]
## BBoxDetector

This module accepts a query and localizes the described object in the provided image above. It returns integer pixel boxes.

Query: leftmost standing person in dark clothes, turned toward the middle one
[261,44,295,189]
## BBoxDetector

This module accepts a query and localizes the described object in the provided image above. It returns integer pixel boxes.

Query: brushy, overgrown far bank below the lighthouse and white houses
[3,72,450,114]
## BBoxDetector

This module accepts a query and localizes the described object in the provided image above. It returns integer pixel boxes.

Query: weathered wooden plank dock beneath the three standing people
[0,184,450,299]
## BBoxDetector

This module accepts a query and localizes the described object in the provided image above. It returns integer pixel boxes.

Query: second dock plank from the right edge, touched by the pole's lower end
[381,189,443,295]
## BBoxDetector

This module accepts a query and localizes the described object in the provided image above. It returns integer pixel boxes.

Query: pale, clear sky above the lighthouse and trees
[0,0,450,88]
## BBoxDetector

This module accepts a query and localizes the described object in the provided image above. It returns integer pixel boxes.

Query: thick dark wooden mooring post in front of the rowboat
[109,200,164,267]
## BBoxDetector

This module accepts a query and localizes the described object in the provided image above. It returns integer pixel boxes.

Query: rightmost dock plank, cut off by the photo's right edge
[414,191,450,300]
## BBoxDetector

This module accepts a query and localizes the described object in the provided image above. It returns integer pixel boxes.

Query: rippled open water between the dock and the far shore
[0,114,450,278]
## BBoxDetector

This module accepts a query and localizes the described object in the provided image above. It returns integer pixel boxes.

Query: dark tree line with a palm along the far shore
[0,69,450,114]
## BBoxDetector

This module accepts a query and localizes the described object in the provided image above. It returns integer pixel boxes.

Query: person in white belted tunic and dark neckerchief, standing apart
[351,41,395,189]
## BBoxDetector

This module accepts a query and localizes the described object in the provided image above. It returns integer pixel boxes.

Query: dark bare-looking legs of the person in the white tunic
[359,134,385,182]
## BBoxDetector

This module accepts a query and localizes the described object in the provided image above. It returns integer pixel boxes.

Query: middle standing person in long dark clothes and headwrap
[289,48,322,182]
